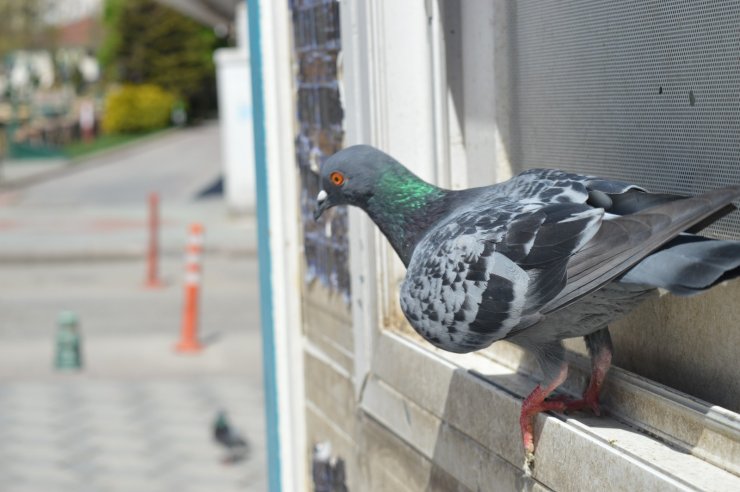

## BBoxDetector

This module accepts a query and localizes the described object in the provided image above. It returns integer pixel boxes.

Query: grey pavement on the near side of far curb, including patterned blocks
[0,255,266,492]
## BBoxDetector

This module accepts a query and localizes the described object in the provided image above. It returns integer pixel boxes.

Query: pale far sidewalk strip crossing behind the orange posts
[0,201,256,263]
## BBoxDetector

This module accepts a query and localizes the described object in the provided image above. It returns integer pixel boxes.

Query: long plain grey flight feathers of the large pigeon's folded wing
[542,186,740,314]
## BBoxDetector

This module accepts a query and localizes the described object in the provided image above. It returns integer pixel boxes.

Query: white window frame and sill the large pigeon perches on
[341,0,740,490]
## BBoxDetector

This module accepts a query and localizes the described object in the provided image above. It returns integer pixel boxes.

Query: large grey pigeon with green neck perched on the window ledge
[314,145,740,463]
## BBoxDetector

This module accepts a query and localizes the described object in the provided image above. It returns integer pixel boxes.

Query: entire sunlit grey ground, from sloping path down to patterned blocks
[0,125,266,491]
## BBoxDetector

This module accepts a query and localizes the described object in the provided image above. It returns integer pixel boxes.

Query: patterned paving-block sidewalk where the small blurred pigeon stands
[0,376,266,492]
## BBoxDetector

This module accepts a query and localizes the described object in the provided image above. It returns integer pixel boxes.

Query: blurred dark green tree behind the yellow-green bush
[98,0,220,121]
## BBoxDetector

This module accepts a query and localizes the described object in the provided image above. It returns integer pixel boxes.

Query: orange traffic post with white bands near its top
[175,223,203,352]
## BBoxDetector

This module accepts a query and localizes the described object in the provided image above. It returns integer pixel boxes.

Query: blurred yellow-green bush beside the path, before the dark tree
[103,84,177,133]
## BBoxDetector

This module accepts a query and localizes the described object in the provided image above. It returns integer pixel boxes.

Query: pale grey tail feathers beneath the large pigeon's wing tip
[619,234,740,296]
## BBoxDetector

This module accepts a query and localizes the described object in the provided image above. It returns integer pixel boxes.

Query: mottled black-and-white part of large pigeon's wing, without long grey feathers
[401,202,603,352]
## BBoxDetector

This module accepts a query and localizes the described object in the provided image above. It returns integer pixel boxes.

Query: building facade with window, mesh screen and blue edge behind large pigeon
[248,0,740,491]
